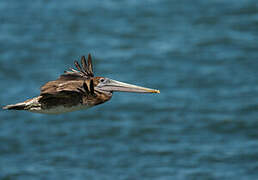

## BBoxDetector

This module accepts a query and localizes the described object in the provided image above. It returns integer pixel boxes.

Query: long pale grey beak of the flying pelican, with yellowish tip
[101,79,160,93]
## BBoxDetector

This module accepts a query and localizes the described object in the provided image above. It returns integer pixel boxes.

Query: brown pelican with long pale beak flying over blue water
[3,54,160,114]
